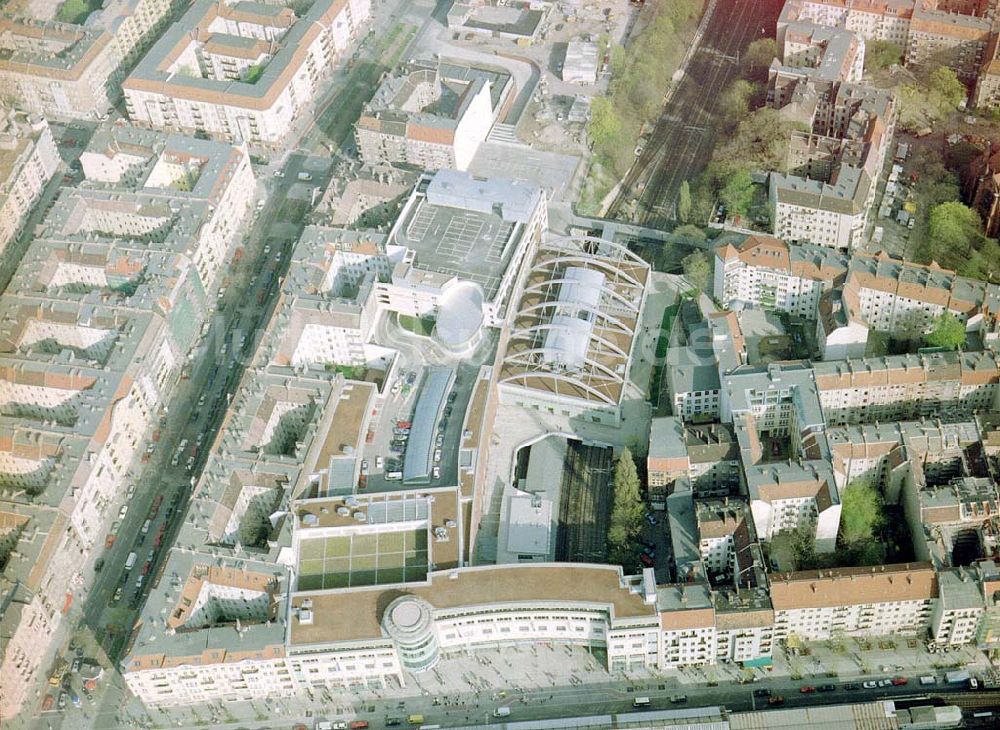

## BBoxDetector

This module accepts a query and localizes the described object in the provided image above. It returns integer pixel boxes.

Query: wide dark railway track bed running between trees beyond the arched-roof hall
[607,0,781,227]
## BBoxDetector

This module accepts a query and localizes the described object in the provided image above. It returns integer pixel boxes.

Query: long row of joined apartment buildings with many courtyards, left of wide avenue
[0,127,253,717]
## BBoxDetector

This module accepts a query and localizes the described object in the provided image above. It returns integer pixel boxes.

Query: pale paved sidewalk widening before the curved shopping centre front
[94,637,989,728]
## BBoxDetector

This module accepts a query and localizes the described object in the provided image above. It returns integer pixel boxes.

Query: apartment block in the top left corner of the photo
[0,0,173,119]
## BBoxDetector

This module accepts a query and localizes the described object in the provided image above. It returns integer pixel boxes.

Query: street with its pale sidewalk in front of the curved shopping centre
[60,644,993,728]
